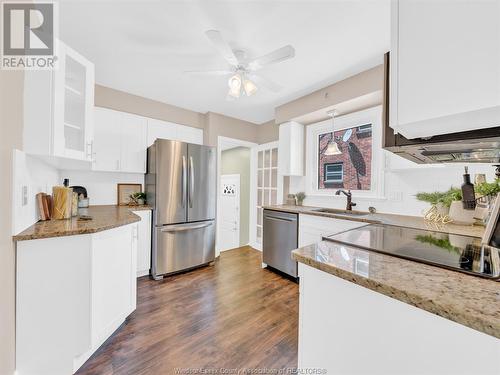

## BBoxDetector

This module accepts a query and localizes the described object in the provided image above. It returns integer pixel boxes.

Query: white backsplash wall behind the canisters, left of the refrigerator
[59,170,144,205]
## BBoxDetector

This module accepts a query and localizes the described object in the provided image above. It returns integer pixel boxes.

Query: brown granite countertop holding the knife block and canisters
[13,205,152,241]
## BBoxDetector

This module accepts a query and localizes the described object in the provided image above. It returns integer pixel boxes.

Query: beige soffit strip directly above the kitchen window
[275,65,384,124]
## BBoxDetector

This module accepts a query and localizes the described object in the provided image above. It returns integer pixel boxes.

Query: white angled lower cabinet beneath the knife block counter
[16,223,138,375]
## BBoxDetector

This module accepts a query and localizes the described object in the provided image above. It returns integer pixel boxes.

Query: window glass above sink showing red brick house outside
[318,124,372,190]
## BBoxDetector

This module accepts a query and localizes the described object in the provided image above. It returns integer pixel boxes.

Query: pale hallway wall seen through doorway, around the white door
[221,147,250,246]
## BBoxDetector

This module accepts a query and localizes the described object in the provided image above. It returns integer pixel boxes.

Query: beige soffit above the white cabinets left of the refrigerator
[94,85,205,128]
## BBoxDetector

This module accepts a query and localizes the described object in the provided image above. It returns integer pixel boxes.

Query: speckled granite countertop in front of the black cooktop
[292,241,500,338]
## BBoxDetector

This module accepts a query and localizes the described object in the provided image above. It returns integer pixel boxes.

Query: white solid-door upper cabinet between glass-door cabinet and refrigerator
[92,107,147,173]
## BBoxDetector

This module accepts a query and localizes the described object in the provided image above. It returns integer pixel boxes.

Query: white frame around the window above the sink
[306,106,385,199]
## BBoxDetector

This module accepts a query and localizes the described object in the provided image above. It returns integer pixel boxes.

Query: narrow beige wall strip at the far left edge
[0,70,24,375]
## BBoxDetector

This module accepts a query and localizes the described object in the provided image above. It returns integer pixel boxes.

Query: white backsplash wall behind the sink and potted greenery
[290,151,495,216]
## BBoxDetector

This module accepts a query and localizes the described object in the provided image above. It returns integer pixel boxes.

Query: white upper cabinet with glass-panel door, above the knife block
[23,42,94,161]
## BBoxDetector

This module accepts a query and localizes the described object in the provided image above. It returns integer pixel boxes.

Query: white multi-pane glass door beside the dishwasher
[256,146,280,244]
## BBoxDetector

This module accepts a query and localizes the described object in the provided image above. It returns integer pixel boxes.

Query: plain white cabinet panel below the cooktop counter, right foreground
[298,262,500,375]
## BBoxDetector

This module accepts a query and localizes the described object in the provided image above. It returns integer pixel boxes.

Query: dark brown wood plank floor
[77,247,298,375]
